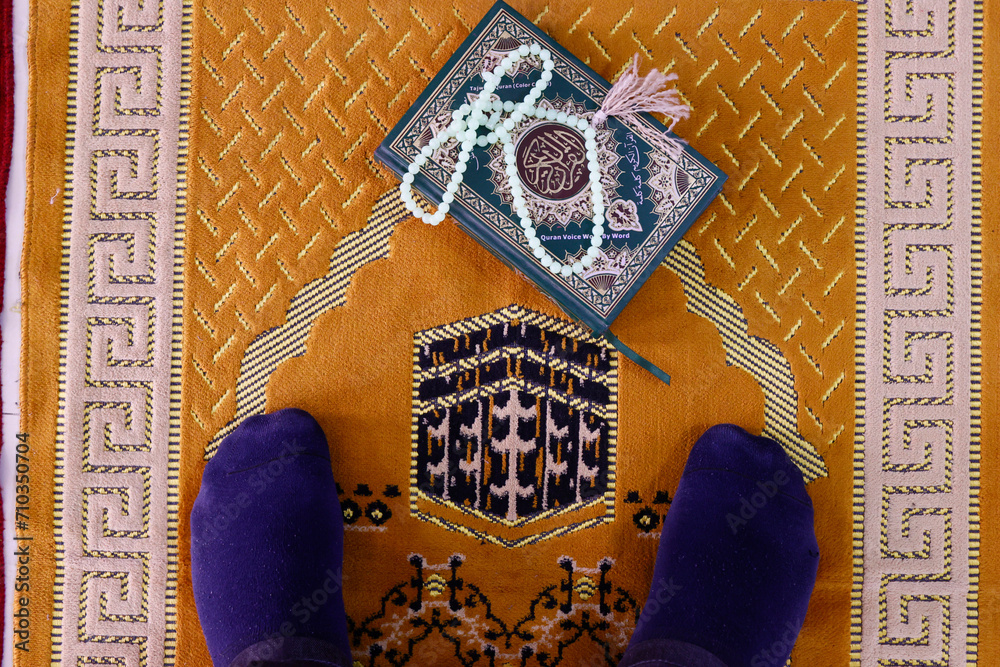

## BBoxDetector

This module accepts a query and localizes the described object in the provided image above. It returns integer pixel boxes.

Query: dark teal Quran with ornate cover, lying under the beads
[375,2,726,335]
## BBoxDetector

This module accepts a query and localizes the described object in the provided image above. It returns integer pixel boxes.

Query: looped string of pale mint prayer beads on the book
[399,42,605,278]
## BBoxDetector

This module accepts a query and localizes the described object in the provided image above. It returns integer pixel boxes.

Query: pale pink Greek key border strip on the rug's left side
[51,0,191,667]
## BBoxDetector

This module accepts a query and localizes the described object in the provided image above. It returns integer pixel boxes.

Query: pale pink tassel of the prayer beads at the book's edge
[593,53,691,155]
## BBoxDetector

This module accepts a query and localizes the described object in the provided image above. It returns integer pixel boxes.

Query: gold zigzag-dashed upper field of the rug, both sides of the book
[188,0,856,464]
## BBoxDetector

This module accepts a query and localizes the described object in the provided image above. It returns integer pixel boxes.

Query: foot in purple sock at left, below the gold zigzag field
[191,409,351,667]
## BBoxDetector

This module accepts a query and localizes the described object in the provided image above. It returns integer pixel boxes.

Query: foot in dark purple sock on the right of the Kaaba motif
[621,425,819,667]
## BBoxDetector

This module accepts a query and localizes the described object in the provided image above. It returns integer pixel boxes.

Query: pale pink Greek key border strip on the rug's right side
[851,0,983,667]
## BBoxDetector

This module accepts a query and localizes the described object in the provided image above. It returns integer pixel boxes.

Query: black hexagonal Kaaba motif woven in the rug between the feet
[410,306,618,546]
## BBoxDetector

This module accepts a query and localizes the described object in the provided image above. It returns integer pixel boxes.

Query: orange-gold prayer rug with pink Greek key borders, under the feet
[17,0,1000,667]
